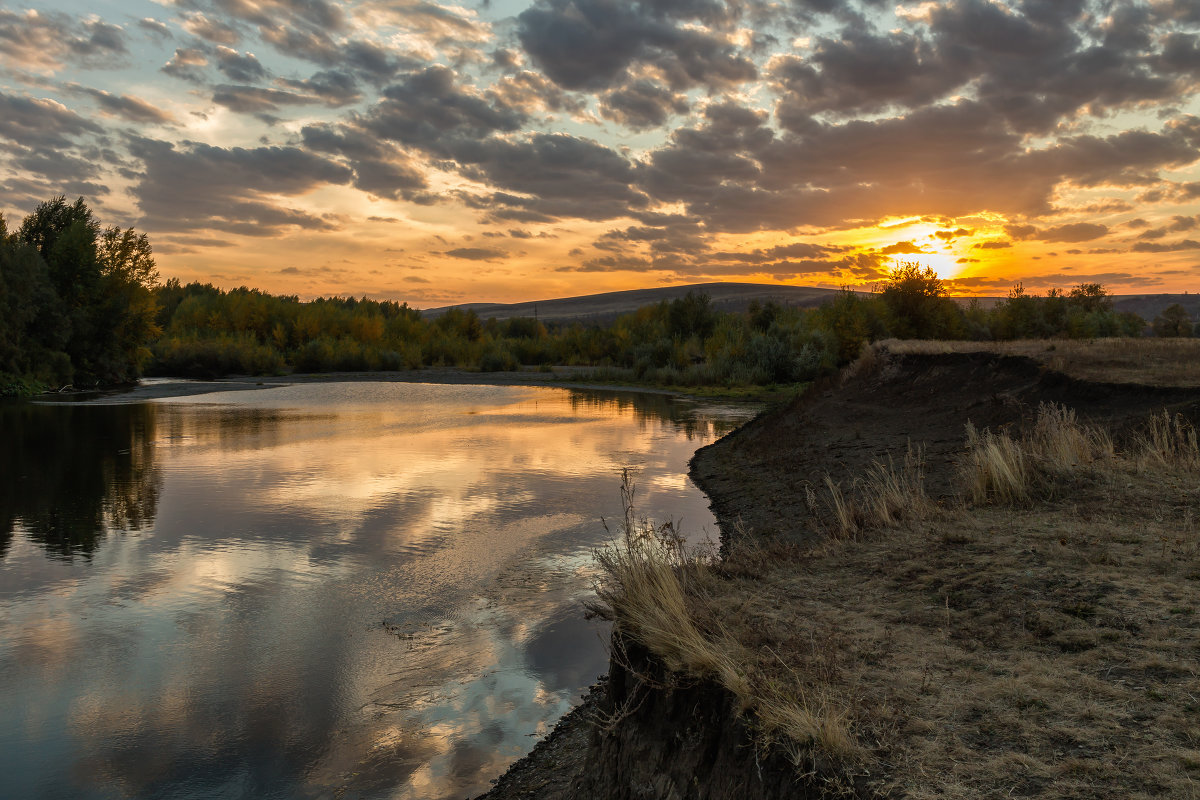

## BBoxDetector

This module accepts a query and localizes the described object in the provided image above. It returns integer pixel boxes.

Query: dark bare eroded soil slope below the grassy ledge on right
[691,353,1200,544]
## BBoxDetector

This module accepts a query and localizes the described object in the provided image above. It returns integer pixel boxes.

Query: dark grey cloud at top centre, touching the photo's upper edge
[517,0,757,89]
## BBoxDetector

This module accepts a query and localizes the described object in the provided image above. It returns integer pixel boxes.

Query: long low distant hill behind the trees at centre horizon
[421,283,854,323]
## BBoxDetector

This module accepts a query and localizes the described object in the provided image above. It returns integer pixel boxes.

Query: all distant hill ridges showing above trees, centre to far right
[421,283,1200,324]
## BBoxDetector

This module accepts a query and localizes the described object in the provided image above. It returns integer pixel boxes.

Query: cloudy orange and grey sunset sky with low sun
[0,0,1200,307]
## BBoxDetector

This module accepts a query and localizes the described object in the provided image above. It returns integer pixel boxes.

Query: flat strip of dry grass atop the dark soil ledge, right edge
[874,338,1200,387]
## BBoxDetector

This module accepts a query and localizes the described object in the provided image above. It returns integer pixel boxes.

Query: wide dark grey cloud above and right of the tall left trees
[130,139,353,236]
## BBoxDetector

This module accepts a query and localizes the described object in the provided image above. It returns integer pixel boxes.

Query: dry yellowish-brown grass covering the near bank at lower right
[704,422,1200,800]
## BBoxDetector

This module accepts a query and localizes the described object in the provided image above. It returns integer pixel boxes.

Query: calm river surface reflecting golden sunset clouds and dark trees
[0,383,752,799]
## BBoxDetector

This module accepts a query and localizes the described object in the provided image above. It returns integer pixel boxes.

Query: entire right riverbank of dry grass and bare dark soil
[472,342,1200,800]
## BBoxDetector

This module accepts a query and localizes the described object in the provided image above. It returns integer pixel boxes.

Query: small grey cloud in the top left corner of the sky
[0,8,128,71]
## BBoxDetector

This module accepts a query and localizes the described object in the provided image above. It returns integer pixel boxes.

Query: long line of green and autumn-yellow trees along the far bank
[0,197,1195,393]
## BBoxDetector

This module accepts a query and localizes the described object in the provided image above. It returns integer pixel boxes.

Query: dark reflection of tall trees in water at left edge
[0,403,162,560]
